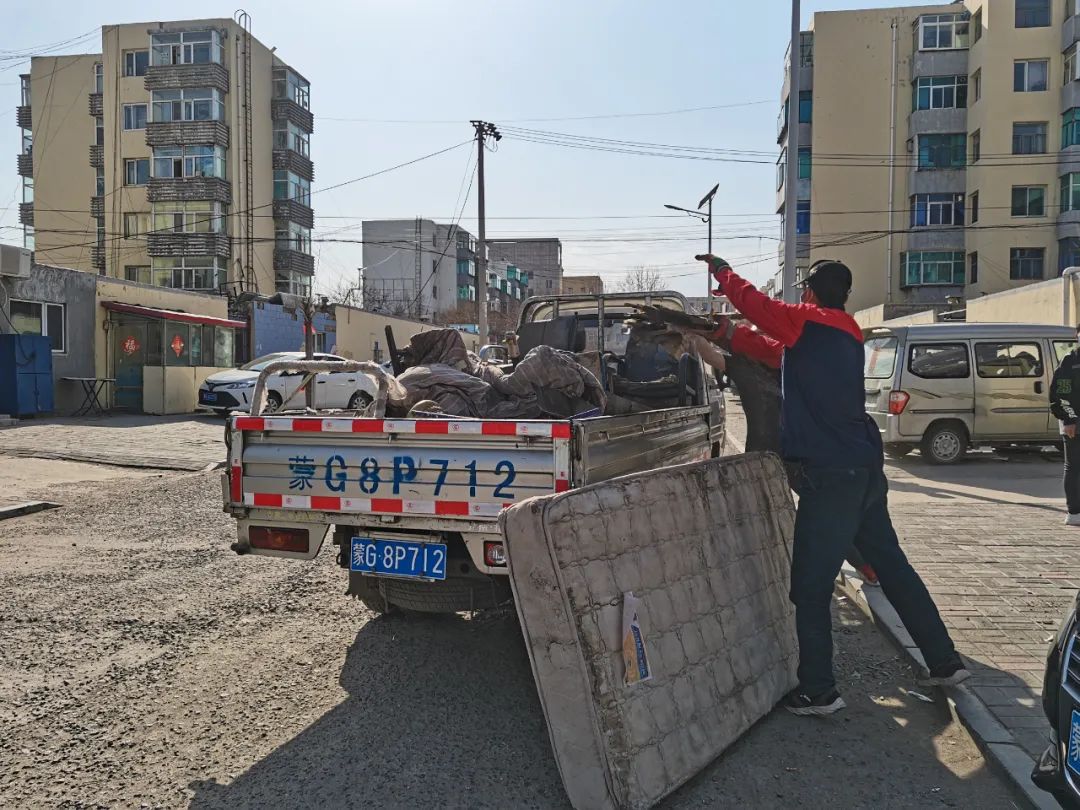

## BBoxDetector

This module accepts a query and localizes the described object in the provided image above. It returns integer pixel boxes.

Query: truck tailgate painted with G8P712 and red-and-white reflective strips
[229,416,570,519]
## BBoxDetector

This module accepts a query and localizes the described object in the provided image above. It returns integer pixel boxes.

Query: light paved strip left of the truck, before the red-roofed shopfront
[0,415,226,471]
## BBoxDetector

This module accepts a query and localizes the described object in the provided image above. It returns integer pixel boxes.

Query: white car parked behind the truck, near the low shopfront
[199,352,378,416]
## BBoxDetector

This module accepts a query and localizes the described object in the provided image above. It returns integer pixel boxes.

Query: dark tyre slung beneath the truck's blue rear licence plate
[349,571,511,613]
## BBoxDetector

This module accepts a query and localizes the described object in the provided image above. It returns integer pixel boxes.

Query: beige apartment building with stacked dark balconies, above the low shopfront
[16,15,314,295]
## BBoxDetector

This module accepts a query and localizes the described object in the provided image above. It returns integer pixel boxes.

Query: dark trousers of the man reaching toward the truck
[791,467,957,697]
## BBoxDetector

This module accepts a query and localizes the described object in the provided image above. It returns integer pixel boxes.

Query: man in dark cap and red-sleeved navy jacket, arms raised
[697,256,969,715]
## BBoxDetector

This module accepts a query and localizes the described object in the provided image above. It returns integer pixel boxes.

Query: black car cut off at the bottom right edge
[1031,593,1080,808]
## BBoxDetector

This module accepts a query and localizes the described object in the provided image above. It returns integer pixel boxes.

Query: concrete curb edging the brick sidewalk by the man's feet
[836,565,1061,810]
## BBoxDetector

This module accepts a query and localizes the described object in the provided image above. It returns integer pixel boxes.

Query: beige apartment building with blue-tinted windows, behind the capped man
[771,0,1080,310]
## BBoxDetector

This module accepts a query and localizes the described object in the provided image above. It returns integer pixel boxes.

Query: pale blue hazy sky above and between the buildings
[0,0,937,295]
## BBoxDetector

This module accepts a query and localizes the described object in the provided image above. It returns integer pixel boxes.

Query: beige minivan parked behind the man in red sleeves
[863,323,1076,464]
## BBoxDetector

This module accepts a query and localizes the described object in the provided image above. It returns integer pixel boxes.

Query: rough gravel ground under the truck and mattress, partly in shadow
[0,473,1018,809]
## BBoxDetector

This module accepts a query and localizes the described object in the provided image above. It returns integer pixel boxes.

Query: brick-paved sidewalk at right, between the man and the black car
[728,401,1080,807]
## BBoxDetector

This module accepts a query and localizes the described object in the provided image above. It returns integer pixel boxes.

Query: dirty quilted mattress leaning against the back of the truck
[501,454,798,810]
